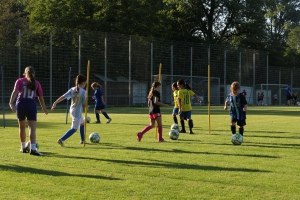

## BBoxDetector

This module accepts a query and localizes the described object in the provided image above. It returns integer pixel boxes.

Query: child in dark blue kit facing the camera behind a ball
[224,82,248,135]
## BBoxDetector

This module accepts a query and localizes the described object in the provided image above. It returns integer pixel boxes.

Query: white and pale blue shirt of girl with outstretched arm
[63,87,86,118]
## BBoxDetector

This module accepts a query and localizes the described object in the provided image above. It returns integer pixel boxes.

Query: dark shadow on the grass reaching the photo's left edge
[0,165,120,180]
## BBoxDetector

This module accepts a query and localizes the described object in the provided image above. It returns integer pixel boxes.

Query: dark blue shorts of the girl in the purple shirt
[16,101,37,121]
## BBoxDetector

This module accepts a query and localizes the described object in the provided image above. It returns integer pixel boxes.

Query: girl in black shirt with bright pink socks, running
[137,82,169,142]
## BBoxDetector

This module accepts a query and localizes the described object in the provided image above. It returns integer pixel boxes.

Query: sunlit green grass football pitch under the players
[0,106,300,199]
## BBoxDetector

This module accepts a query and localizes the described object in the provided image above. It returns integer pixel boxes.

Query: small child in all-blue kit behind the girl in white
[91,82,112,124]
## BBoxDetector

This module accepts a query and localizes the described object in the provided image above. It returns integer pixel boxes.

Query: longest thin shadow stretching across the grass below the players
[45,152,271,173]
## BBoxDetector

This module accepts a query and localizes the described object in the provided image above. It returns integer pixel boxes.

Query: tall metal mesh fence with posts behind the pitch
[0,27,300,107]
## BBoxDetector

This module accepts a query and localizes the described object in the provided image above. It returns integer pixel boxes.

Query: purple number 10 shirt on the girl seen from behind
[14,78,43,104]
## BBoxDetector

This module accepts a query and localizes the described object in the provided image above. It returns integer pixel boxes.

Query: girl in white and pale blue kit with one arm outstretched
[51,75,86,147]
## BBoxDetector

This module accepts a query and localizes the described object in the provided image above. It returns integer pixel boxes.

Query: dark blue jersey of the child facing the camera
[226,93,247,120]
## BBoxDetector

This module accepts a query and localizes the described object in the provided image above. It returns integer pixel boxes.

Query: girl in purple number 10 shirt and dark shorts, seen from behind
[9,66,48,156]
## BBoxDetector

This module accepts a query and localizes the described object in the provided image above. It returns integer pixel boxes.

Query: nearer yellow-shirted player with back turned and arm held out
[177,79,202,134]
